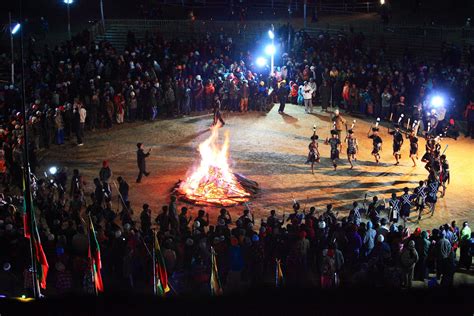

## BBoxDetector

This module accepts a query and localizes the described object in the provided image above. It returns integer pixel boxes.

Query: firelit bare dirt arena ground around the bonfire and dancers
[42,105,474,228]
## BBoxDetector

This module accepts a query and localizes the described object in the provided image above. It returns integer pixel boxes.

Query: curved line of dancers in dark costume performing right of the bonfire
[307,111,450,220]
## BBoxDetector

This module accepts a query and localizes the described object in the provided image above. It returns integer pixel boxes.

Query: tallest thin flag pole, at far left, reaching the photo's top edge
[20,0,41,298]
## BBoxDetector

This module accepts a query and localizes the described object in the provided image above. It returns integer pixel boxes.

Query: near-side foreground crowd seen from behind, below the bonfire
[0,175,474,296]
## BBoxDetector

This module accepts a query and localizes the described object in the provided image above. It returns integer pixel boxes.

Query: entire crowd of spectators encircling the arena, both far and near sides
[0,22,474,294]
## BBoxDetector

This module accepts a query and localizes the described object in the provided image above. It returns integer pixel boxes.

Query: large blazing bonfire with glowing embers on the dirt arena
[174,126,258,206]
